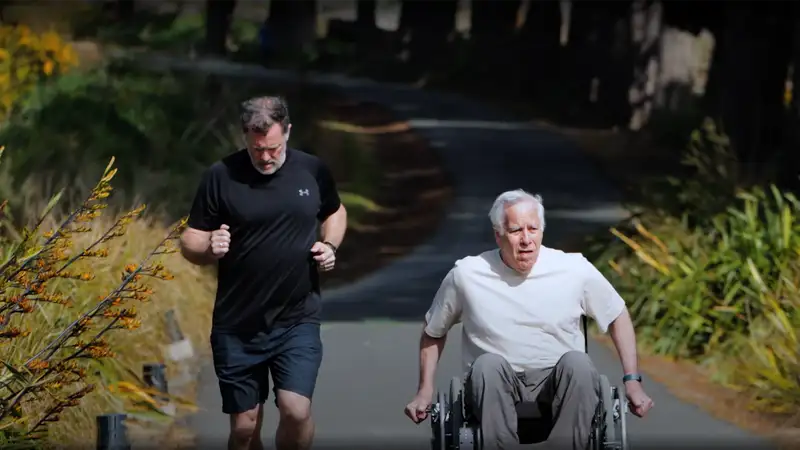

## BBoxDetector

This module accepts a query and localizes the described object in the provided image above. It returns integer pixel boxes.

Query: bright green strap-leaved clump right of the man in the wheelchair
[612,188,800,357]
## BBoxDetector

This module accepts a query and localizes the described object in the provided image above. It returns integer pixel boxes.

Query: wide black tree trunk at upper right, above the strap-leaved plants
[707,0,795,182]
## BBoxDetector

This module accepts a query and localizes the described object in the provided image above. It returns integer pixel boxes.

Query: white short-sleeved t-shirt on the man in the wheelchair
[425,246,625,372]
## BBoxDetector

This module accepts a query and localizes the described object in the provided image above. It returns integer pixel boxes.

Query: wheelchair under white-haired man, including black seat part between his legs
[429,317,629,450]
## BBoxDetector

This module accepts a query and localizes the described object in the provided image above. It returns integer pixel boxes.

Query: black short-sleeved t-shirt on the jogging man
[188,148,340,332]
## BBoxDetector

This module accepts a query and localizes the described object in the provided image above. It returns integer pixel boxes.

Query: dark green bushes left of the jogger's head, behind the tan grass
[0,63,231,216]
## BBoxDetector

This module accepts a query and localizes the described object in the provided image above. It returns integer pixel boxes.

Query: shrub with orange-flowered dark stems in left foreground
[0,149,185,448]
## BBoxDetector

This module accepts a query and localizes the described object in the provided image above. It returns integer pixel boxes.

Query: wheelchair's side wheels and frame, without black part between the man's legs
[430,316,628,450]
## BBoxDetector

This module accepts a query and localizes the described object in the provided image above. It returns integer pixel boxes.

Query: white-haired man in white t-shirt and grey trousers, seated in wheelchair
[405,190,653,450]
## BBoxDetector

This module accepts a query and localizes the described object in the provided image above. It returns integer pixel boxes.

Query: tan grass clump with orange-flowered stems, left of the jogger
[0,150,213,448]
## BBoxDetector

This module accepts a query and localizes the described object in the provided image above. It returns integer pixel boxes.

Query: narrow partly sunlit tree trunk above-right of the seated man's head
[628,0,663,131]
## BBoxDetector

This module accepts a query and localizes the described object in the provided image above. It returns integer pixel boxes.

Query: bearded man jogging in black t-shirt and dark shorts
[181,97,347,450]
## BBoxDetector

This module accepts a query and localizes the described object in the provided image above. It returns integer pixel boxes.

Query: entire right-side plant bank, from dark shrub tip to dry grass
[598,121,800,412]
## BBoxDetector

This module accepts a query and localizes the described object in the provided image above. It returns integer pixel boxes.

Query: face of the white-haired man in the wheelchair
[495,202,543,275]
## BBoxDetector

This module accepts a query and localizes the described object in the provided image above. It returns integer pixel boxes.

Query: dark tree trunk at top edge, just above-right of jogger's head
[267,0,317,55]
